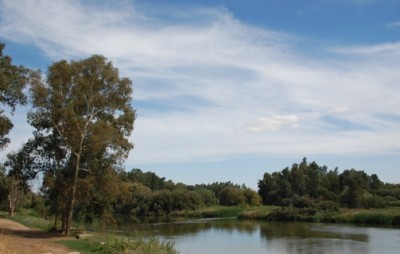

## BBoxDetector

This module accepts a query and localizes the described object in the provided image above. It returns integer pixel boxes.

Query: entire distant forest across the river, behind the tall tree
[0,158,400,225]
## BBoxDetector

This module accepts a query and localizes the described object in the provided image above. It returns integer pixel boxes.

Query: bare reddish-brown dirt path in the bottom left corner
[0,218,76,254]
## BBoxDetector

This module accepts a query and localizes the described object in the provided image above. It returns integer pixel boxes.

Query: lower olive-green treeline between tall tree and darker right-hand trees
[115,169,261,216]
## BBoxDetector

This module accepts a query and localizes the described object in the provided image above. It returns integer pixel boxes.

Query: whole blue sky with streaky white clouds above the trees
[0,0,400,189]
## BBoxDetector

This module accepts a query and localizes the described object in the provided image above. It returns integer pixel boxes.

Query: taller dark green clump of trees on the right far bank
[258,158,400,212]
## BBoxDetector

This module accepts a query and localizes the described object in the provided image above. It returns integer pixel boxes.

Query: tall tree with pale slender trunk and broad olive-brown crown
[28,55,136,234]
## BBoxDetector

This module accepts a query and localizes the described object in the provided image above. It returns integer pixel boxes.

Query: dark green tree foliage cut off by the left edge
[0,43,29,150]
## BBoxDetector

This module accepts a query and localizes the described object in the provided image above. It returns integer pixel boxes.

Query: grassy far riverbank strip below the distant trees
[148,206,400,227]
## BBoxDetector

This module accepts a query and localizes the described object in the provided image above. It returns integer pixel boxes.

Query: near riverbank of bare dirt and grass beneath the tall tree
[0,209,178,254]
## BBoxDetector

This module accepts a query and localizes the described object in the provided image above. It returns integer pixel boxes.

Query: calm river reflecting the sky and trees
[113,216,400,254]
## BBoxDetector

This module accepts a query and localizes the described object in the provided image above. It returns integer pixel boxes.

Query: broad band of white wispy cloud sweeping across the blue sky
[0,0,400,166]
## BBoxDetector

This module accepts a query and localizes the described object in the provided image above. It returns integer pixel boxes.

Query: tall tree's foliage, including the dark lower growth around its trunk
[28,55,136,234]
